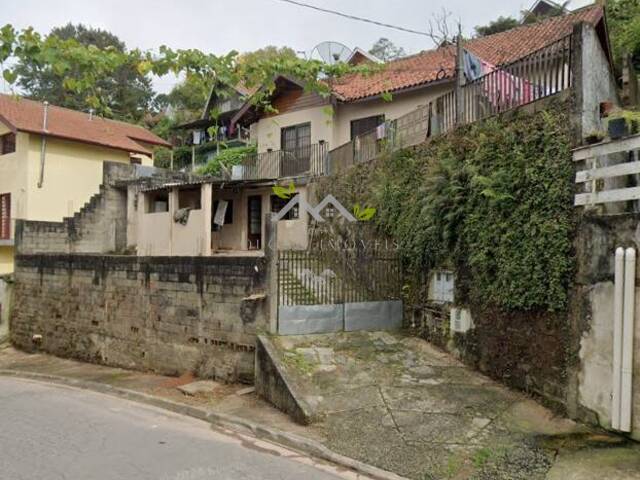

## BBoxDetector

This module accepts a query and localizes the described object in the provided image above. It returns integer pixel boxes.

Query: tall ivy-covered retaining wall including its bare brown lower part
[319,101,575,404]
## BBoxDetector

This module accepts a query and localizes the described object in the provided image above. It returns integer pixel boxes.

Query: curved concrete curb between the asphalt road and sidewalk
[0,369,408,480]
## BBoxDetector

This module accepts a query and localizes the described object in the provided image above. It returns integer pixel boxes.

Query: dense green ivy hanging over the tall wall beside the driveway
[328,104,574,310]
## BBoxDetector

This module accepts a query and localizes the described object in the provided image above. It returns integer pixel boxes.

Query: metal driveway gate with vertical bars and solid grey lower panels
[278,250,402,335]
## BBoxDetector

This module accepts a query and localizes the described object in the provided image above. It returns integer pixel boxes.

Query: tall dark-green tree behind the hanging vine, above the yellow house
[16,23,155,122]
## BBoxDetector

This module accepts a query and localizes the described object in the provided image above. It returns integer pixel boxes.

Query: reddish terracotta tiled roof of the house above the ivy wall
[332,5,604,101]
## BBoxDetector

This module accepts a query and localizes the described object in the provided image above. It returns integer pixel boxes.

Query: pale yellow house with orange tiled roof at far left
[0,95,171,274]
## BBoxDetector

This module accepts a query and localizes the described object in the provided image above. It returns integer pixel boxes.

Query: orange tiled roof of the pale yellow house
[0,94,171,154]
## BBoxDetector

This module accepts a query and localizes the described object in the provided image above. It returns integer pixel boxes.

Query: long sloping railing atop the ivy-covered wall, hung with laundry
[325,35,573,175]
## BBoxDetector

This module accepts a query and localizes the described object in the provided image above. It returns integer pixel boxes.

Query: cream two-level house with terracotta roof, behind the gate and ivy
[129,6,610,256]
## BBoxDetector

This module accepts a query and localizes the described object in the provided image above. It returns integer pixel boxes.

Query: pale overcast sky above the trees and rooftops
[0,0,593,90]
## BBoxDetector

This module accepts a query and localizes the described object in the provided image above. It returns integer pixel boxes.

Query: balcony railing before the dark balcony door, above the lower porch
[231,143,329,180]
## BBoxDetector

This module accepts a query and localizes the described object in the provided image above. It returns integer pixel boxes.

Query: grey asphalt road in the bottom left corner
[0,378,361,480]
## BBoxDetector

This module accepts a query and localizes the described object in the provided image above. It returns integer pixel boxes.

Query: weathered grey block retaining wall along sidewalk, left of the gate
[11,254,269,382]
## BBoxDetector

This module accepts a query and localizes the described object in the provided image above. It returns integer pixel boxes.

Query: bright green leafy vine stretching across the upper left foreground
[0,24,379,122]
